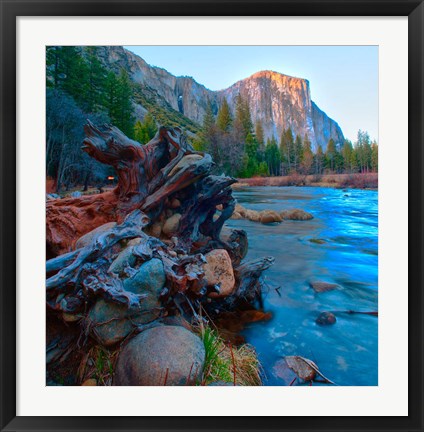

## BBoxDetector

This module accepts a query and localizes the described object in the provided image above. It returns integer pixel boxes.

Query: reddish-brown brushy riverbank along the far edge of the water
[233,173,378,190]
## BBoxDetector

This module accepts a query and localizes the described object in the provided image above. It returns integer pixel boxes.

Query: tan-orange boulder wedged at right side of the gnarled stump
[203,249,235,297]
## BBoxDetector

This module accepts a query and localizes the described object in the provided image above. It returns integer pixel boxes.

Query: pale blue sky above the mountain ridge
[125,46,378,141]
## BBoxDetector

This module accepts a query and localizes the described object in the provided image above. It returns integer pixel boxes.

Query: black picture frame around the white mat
[0,0,424,431]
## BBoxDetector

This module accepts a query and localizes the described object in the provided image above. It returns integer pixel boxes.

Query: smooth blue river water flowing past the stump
[227,187,378,386]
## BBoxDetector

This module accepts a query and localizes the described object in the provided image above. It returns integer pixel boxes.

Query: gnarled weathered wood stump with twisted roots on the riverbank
[46,123,273,352]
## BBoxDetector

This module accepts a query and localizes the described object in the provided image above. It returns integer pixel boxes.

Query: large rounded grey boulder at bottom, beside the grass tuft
[114,326,205,386]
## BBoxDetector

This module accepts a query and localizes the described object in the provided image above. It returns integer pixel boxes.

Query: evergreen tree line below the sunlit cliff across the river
[195,95,378,178]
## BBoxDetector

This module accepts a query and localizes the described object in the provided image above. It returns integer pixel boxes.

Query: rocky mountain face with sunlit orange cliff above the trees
[99,46,344,150]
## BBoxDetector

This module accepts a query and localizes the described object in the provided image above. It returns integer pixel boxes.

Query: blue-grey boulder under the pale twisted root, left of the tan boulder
[124,258,166,298]
